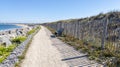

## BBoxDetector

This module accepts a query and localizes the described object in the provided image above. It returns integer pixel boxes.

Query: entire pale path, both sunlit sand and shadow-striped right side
[21,27,102,67]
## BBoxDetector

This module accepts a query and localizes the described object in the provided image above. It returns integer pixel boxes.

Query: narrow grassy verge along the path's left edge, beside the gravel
[15,27,40,67]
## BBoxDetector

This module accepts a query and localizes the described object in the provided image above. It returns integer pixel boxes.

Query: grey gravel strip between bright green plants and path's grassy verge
[0,35,33,67]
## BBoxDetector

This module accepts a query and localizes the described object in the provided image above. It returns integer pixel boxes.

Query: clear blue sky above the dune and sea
[0,0,120,23]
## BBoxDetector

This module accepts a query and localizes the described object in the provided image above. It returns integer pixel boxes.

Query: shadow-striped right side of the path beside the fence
[46,26,103,67]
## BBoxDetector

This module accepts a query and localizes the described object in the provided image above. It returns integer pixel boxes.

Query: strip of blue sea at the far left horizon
[0,23,21,31]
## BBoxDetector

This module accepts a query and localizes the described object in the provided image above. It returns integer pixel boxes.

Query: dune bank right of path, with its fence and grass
[43,11,120,67]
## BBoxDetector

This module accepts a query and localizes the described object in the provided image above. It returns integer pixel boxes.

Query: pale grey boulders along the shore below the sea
[0,26,32,45]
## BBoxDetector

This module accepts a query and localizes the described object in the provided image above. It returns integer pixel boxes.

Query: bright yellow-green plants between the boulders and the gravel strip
[0,36,27,63]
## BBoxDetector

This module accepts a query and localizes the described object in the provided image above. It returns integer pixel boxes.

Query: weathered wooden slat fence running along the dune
[43,18,120,52]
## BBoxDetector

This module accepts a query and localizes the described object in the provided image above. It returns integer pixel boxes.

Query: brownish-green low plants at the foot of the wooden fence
[47,27,120,67]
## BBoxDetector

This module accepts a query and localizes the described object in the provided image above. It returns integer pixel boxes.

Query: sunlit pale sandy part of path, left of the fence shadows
[21,27,68,67]
